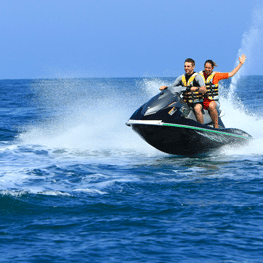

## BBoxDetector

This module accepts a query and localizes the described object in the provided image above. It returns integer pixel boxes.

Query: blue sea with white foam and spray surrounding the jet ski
[0,76,263,263]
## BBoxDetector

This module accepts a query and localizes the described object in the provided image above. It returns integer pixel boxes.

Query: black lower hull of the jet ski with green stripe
[131,123,251,156]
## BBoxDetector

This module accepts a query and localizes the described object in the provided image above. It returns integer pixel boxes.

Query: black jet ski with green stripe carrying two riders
[126,87,252,156]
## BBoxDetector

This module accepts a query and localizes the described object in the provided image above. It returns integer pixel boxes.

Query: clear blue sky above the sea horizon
[0,0,263,79]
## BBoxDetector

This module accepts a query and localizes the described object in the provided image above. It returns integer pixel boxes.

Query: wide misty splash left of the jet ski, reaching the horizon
[19,79,161,155]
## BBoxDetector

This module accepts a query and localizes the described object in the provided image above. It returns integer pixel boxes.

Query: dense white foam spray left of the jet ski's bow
[19,78,159,157]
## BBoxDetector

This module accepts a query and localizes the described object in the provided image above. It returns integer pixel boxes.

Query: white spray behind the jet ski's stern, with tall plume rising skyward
[220,7,263,157]
